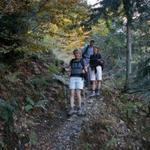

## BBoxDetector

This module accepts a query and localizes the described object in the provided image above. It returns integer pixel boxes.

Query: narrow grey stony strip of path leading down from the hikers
[51,95,102,150]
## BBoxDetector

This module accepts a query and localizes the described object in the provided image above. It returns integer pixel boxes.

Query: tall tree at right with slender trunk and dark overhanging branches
[86,0,149,90]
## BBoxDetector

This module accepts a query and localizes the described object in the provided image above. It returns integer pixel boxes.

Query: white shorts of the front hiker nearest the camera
[69,77,84,90]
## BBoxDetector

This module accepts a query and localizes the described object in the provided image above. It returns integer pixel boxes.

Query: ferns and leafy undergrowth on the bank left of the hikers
[0,54,66,150]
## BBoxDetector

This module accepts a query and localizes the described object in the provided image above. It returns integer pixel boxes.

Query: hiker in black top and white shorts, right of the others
[90,47,104,96]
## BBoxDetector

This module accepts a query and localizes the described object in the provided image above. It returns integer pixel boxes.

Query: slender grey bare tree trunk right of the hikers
[125,21,132,90]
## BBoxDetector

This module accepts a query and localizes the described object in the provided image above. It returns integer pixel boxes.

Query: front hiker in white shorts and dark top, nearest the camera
[65,49,87,115]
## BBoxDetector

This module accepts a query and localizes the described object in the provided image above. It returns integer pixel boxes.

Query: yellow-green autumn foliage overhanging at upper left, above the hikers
[0,0,88,54]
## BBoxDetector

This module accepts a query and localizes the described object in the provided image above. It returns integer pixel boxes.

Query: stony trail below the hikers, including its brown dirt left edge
[33,88,104,150]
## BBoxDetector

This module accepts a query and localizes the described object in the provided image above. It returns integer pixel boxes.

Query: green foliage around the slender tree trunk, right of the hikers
[87,0,150,89]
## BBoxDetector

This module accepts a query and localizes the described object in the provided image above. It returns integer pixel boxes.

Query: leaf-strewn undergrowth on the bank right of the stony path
[79,88,150,150]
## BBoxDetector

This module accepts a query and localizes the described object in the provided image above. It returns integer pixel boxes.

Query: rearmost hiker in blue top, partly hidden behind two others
[82,40,95,85]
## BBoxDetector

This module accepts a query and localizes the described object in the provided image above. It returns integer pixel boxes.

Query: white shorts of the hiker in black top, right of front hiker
[90,66,102,81]
